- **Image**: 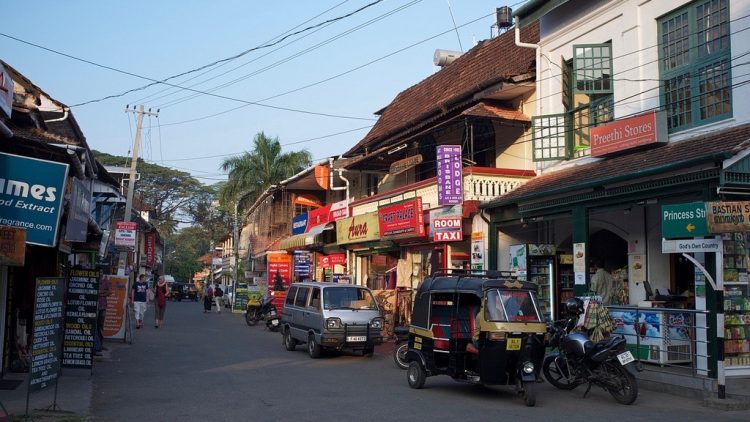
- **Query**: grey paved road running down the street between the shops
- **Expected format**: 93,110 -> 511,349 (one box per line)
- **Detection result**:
91,302 -> 747,422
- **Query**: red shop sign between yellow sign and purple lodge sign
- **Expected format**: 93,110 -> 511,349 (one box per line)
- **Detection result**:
378,196 -> 425,238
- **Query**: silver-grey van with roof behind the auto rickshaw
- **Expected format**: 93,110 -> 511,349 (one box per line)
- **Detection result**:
281,282 -> 383,358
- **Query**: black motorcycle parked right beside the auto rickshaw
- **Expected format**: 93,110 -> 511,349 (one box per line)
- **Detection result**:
542,298 -> 638,404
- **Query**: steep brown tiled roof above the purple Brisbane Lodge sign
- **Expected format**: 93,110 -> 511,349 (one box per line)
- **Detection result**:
344,23 -> 539,155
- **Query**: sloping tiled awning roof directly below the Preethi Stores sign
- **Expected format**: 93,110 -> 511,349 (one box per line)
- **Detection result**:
483,124 -> 750,208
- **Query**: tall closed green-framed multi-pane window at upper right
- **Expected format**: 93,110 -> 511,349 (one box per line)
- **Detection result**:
658,0 -> 732,132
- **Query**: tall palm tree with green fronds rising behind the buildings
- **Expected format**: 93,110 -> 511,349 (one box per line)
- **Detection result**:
220,132 -> 312,203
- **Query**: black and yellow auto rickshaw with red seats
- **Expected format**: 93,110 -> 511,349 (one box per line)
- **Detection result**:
406,270 -> 546,406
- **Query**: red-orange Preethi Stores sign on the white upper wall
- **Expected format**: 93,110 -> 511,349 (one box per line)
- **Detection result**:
590,111 -> 668,157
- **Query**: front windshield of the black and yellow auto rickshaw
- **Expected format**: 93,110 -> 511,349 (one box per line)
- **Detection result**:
485,289 -> 541,322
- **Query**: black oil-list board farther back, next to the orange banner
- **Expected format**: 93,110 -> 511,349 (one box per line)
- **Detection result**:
62,269 -> 99,368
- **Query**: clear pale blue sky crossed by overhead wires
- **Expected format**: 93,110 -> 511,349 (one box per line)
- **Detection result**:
0,0 -> 524,184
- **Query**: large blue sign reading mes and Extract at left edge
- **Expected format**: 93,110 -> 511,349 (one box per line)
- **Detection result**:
0,152 -> 68,246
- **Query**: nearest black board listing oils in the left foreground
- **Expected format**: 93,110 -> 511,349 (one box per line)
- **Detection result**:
29,277 -> 65,391
